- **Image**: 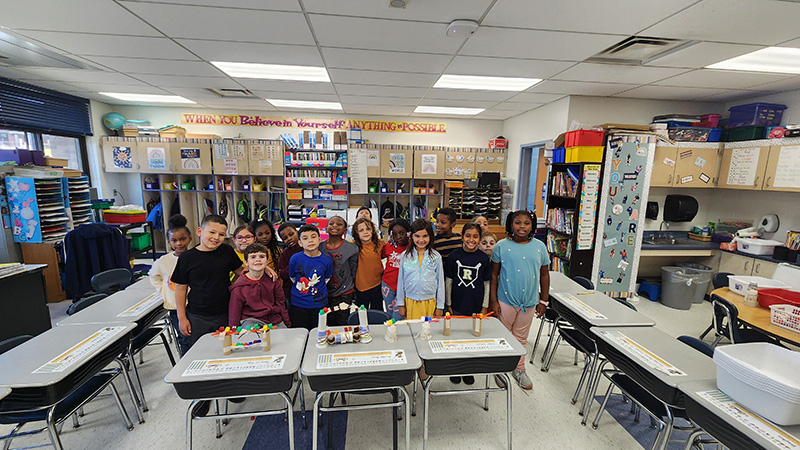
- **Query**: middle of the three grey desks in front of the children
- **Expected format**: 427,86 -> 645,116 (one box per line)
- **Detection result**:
300,325 -> 422,450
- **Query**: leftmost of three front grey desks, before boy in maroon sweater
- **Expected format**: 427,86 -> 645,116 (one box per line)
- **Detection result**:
164,328 -> 308,449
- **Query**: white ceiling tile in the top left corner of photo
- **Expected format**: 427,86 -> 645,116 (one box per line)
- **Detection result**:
0,0 -> 159,36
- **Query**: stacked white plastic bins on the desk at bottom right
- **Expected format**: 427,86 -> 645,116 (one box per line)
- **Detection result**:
714,344 -> 800,426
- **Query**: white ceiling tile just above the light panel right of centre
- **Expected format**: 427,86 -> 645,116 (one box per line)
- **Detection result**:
444,55 -> 574,79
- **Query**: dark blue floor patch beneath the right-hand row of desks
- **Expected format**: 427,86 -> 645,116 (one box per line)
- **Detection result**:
587,394 -> 716,450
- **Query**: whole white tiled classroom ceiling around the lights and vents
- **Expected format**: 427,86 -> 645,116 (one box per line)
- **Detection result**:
0,0 -> 800,120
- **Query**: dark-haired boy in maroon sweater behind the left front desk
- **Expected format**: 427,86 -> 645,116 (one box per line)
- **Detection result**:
228,243 -> 292,327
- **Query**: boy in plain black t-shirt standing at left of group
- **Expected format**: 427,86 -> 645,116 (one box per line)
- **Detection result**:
172,214 -> 277,347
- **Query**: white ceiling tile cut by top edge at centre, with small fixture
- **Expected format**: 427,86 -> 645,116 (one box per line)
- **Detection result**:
303,0 -> 492,21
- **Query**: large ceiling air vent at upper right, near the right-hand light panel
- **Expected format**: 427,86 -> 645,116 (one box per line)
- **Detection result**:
586,36 -> 697,66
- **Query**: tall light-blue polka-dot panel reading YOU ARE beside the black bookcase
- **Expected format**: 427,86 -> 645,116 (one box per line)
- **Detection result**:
592,134 -> 656,297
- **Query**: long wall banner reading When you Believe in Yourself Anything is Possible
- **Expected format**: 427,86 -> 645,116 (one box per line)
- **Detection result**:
181,113 -> 447,133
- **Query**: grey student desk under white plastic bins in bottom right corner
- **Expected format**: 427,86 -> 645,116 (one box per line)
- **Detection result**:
679,380 -> 800,450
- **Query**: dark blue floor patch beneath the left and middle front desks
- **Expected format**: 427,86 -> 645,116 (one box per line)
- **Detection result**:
242,411 -> 347,450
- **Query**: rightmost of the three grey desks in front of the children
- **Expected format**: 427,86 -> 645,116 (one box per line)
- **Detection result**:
410,317 -> 525,449
